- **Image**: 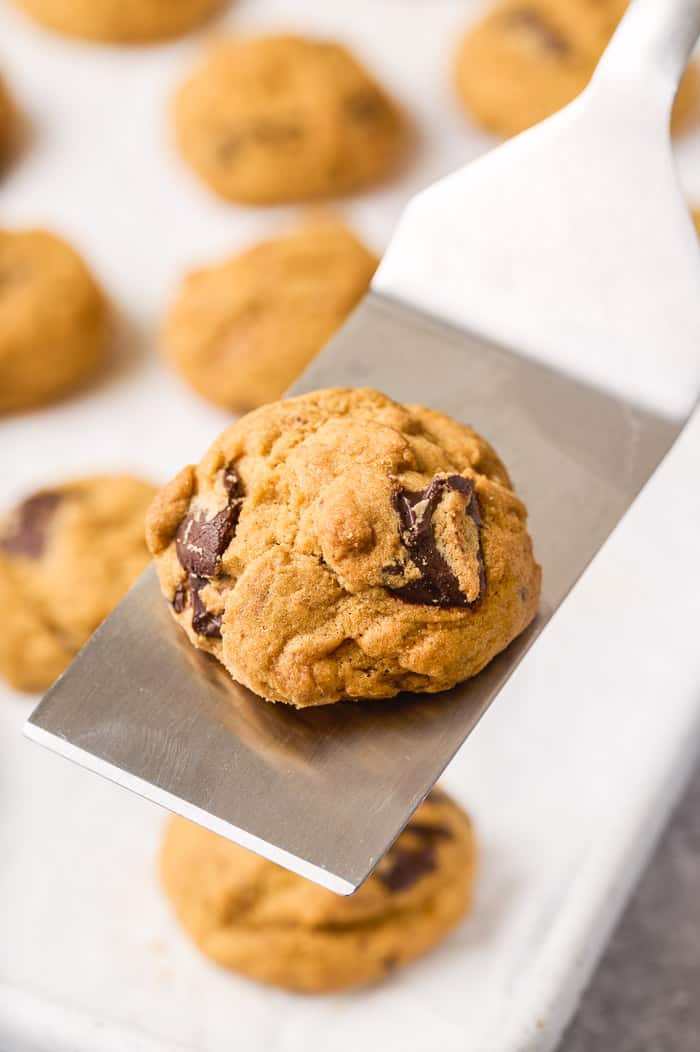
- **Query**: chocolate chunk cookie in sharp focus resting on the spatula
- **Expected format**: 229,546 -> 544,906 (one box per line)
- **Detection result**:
146,388 -> 540,707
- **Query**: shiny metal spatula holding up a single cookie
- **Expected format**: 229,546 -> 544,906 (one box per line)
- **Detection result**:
26,0 -> 700,893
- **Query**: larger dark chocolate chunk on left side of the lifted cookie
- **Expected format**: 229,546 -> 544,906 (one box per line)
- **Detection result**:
175,465 -> 243,578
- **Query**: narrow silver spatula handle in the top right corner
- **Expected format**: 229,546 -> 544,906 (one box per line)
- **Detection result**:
596,0 -> 700,107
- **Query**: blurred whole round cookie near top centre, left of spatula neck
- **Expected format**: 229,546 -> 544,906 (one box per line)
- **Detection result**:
175,36 -> 405,204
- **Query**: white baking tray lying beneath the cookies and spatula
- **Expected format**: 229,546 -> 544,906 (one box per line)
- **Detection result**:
0,0 -> 700,1052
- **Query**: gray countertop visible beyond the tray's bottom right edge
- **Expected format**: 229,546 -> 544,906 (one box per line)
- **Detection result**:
560,769 -> 700,1052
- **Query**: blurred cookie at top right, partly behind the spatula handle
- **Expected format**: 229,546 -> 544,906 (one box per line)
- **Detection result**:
455,0 -> 700,137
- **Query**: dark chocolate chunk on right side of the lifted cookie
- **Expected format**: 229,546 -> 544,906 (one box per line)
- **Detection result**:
389,474 -> 486,609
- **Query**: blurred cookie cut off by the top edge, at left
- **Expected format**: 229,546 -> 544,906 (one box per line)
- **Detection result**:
10,0 -> 224,44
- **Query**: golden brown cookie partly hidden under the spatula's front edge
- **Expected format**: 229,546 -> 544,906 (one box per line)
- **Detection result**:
161,790 -> 476,993
